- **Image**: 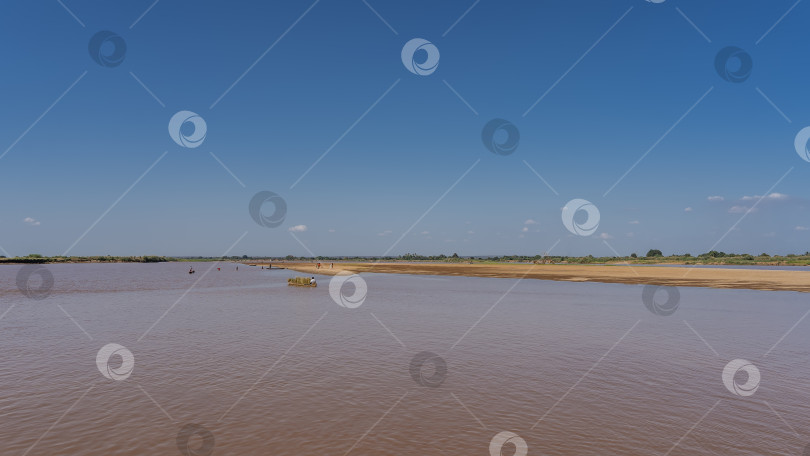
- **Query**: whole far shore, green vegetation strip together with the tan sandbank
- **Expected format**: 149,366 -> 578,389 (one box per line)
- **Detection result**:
0,256 -> 810,293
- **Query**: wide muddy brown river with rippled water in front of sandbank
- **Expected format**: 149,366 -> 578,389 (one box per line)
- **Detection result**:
0,263 -> 810,456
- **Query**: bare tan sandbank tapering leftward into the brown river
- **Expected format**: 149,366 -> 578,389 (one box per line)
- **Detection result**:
270,262 -> 810,293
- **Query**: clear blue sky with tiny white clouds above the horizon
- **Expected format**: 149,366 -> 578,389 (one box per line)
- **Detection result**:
0,0 -> 810,255
